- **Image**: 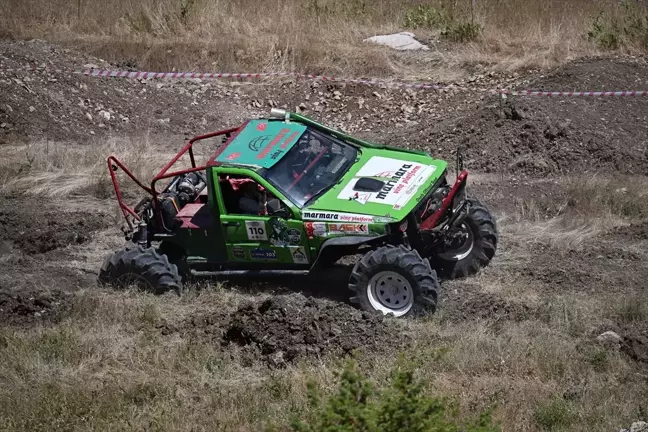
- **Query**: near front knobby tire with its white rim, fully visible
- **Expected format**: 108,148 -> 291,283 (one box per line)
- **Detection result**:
349,245 -> 439,317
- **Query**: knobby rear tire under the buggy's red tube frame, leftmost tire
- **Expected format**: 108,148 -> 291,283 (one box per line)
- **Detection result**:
99,244 -> 182,295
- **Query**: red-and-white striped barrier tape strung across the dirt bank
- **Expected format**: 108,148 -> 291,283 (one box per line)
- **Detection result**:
0,67 -> 648,97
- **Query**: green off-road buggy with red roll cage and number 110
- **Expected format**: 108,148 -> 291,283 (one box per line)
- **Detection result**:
99,109 -> 498,316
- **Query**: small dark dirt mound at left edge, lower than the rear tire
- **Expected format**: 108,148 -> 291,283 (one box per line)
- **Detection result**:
0,290 -> 71,325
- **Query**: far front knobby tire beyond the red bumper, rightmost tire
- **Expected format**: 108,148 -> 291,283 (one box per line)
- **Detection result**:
430,198 -> 499,279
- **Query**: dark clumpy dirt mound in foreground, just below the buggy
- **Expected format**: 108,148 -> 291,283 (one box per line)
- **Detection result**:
182,294 -> 408,366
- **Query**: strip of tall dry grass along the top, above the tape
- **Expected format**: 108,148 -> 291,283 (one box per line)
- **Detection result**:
0,0 -> 642,78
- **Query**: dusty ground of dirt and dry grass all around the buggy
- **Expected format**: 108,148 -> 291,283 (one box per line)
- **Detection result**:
0,41 -> 648,431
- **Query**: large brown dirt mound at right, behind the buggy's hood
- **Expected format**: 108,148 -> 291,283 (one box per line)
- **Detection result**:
374,58 -> 648,175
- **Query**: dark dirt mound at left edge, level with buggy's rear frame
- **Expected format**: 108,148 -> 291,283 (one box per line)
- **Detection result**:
0,197 -> 109,255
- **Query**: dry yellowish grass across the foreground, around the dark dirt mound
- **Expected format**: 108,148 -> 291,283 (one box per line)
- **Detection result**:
0,290 -> 648,431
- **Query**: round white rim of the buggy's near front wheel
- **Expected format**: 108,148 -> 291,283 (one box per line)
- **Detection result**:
367,271 -> 414,317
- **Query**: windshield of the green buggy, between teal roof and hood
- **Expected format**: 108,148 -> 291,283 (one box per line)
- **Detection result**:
265,129 -> 358,208
